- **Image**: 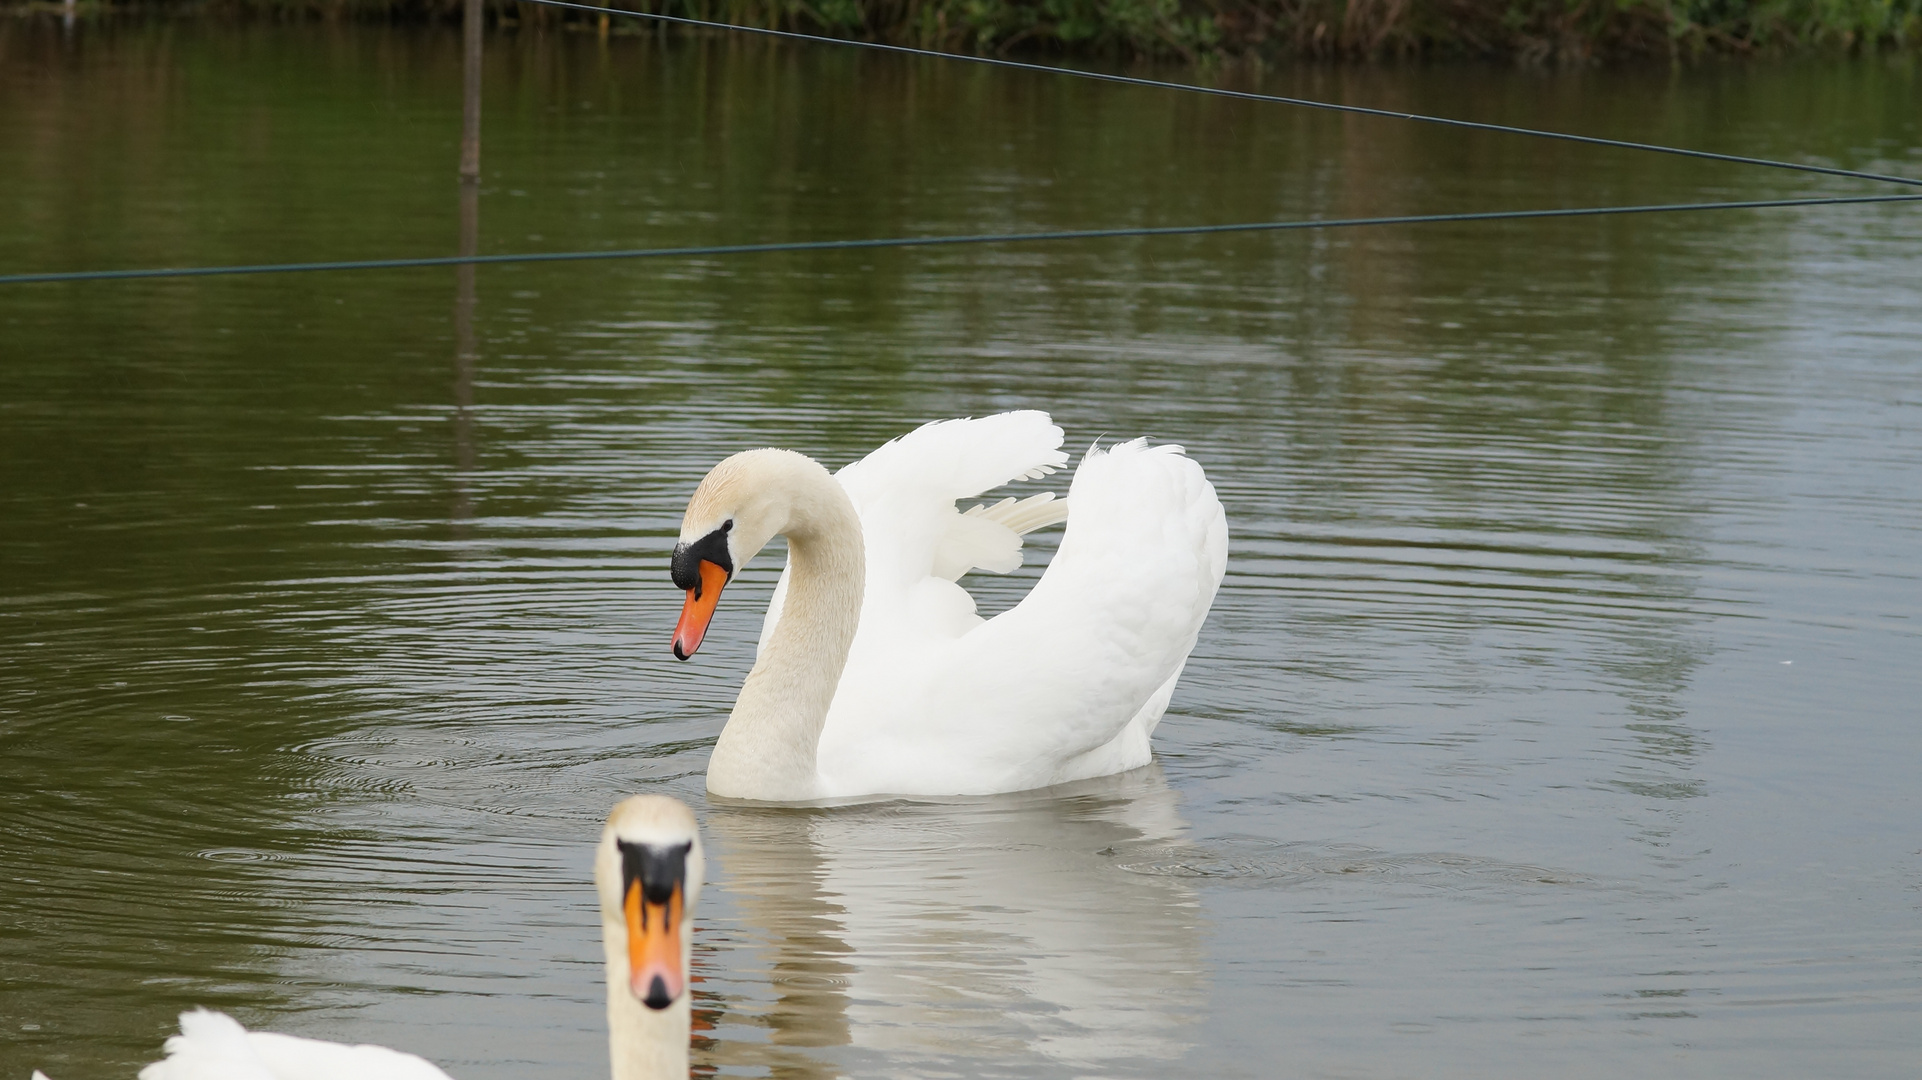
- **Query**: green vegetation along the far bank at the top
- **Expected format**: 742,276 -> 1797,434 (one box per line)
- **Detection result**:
0,0 -> 1922,63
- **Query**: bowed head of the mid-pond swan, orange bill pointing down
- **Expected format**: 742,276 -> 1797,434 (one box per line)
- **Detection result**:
673,450 -> 838,659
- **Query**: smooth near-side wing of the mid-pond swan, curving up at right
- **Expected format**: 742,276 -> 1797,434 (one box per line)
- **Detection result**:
823,440 -> 1228,794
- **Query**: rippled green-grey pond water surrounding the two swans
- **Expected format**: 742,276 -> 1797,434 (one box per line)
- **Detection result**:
0,19 -> 1922,1080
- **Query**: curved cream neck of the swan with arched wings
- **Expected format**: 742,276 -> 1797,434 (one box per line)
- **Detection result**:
707,455 -> 867,801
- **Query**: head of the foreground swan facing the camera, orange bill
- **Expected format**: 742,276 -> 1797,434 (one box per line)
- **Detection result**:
594,796 -> 705,1011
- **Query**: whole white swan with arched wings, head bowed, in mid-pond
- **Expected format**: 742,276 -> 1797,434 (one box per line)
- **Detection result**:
673,411 -> 1228,801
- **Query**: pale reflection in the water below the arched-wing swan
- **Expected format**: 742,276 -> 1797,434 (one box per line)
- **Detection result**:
696,765 -> 1207,1076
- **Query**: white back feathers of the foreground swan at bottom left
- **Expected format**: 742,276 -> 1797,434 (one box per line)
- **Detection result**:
140,1009 -> 450,1080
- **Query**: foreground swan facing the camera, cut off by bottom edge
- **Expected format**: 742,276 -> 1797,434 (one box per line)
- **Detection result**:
60,796 -> 705,1080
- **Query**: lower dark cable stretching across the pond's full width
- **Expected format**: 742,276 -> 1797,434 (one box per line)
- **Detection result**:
0,194 -> 1922,284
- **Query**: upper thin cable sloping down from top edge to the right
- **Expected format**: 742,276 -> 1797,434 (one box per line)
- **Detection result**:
527,0 -> 1922,186
